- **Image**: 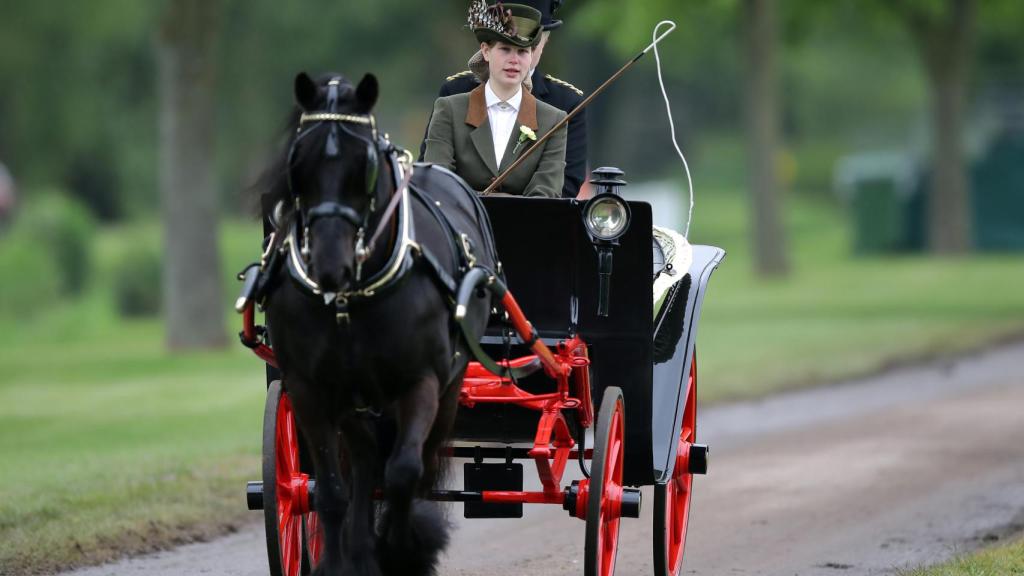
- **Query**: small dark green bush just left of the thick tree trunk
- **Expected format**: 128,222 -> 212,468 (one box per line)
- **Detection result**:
113,240 -> 163,318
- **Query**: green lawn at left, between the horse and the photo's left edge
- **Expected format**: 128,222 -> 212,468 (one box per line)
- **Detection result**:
0,218 -> 264,574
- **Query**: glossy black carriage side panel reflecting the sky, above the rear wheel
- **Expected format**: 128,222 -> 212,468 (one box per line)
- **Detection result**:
651,245 -> 725,483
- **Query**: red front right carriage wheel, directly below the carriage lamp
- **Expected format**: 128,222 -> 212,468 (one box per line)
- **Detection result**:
584,386 -> 626,576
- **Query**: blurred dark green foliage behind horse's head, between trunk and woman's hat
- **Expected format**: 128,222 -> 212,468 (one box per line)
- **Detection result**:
216,0 -> 464,205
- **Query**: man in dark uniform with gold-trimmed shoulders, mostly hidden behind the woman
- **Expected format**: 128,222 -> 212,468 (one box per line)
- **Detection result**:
420,0 -> 587,198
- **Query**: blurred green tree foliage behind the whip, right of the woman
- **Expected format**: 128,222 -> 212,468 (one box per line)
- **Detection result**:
573,0 -> 742,170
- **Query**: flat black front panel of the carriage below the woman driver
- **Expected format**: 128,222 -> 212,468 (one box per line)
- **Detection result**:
455,197 -> 654,485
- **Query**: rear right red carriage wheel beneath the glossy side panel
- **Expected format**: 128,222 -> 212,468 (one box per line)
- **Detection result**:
654,352 -> 697,576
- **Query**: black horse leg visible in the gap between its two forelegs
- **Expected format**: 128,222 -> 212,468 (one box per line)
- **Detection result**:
342,418 -> 380,576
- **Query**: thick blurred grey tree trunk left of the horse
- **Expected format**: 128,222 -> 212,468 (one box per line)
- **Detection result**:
158,0 -> 227,348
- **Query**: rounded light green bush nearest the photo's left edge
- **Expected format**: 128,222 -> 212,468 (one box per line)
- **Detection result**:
16,192 -> 96,296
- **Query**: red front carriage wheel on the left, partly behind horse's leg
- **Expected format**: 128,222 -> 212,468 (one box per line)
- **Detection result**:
263,380 -> 309,576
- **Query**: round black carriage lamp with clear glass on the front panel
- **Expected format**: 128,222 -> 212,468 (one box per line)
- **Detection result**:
583,167 -> 631,317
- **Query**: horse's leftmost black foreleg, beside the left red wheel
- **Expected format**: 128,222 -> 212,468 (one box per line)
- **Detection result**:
292,384 -> 348,575
